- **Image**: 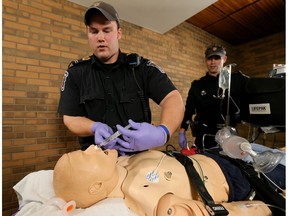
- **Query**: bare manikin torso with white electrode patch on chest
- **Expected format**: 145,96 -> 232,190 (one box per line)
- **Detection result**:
109,150 -> 228,215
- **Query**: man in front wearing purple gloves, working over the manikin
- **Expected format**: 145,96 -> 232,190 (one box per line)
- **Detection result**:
58,2 -> 184,154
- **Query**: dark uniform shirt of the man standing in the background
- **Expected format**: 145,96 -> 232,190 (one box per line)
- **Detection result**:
181,71 -> 248,130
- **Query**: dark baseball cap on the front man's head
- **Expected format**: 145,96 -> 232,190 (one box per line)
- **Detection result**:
84,1 -> 120,27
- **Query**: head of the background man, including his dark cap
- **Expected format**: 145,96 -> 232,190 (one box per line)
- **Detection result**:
205,44 -> 227,76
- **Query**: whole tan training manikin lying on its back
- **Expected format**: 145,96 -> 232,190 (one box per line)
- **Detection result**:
53,146 -> 271,216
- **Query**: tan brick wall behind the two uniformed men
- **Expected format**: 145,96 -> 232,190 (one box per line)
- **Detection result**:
2,0 -> 285,216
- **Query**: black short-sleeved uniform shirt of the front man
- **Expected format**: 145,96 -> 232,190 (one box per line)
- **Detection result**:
58,51 -> 176,144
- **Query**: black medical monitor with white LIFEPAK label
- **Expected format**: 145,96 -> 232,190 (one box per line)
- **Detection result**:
240,77 -> 285,127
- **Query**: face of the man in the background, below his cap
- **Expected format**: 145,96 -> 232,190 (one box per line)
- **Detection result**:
206,55 -> 227,76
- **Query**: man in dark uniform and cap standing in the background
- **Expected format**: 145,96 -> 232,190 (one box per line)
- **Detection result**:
178,44 -> 248,151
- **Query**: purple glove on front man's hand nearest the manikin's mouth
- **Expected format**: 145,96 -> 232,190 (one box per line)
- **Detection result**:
91,122 -> 117,146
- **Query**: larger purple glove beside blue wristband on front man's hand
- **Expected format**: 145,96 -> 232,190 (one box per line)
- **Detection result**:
116,120 -> 169,152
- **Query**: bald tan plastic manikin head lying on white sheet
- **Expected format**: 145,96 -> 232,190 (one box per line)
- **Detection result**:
53,145 -> 119,208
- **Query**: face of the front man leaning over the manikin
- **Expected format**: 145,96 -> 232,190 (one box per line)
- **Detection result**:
87,14 -> 122,64
